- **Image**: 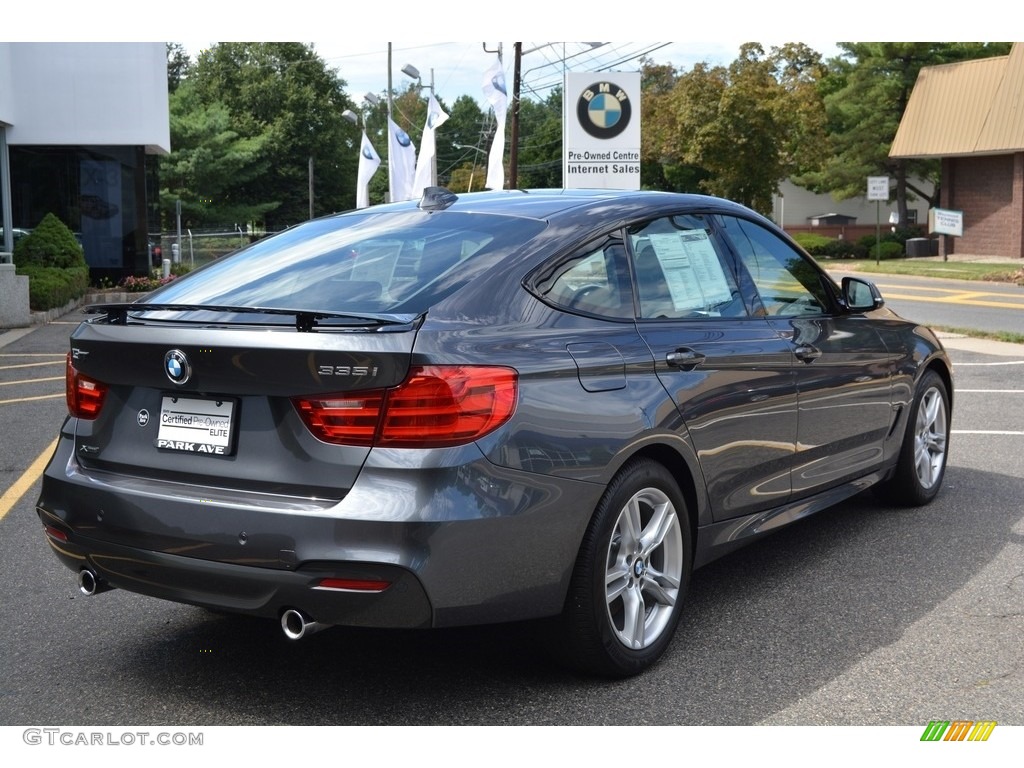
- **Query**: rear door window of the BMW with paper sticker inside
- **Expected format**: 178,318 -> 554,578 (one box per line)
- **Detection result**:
630,215 -> 746,319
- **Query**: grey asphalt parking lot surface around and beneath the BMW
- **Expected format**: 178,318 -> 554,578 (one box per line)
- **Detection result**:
0,312 -> 1024,732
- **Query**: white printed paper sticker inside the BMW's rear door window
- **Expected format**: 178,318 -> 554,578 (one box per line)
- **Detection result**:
648,229 -> 732,310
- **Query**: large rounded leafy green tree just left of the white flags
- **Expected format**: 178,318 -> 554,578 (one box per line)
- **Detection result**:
163,43 -> 358,229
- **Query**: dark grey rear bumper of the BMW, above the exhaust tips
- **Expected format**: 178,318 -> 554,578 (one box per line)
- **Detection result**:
37,433 -> 601,628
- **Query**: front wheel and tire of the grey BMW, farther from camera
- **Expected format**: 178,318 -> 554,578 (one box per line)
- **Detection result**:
879,371 -> 950,507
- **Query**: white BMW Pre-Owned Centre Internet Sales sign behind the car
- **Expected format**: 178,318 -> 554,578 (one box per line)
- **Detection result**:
562,72 -> 640,189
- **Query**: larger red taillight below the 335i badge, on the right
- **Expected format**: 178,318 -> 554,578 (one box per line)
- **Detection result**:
294,366 -> 517,449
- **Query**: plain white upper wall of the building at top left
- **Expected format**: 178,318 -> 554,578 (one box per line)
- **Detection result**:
0,43 -> 171,154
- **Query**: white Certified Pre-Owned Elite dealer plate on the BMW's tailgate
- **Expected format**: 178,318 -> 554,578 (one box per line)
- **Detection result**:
157,395 -> 234,456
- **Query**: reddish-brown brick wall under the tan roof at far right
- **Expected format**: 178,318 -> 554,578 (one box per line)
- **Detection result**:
942,153 -> 1024,258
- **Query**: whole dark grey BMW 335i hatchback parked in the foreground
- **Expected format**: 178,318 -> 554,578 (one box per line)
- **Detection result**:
38,188 -> 953,677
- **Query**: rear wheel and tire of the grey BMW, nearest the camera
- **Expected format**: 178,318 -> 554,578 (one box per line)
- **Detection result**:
561,459 -> 693,678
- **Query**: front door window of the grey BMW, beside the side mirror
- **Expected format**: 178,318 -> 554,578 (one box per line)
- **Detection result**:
719,216 -> 830,317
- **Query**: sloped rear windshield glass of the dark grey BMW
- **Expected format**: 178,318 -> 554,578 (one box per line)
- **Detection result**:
146,211 -> 546,314
